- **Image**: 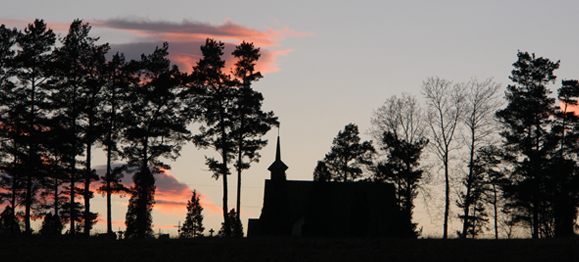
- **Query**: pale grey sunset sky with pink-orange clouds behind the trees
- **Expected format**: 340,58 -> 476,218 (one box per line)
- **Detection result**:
0,0 -> 579,236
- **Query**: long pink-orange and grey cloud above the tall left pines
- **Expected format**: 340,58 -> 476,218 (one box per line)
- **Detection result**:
92,19 -> 312,74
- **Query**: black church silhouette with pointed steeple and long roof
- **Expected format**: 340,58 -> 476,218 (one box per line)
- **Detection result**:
247,136 -> 411,237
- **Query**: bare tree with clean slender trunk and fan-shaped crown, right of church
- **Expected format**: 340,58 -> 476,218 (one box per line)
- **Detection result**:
422,77 -> 466,239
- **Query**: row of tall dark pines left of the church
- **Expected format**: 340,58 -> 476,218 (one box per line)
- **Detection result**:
0,19 -> 278,238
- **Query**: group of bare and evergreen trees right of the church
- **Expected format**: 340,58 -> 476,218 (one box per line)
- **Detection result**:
314,52 -> 579,238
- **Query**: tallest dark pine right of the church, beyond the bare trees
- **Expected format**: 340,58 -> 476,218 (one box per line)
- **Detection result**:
496,51 -> 559,238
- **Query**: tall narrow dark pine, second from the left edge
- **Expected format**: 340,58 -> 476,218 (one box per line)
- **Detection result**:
10,19 -> 56,234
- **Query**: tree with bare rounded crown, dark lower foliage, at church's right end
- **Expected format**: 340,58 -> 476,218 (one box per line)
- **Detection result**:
371,94 -> 428,237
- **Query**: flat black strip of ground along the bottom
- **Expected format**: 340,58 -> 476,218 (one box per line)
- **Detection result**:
0,237 -> 579,262
